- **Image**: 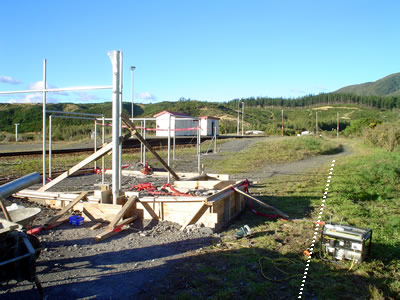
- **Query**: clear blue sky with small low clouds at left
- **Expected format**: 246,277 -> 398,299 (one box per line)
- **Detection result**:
0,0 -> 400,103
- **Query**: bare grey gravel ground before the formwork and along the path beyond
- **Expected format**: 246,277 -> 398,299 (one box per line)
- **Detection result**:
0,139 -> 349,299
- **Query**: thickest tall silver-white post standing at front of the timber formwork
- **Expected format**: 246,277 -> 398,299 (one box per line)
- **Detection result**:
110,50 -> 120,205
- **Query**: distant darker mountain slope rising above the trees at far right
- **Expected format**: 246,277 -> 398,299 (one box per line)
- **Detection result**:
336,73 -> 400,96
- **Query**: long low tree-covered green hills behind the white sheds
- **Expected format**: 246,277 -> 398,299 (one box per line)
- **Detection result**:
0,91 -> 400,141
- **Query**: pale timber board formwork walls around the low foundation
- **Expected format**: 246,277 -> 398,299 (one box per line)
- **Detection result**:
14,181 -> 245,230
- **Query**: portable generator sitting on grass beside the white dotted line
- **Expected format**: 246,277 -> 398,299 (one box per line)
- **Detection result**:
321,224 -> 372,263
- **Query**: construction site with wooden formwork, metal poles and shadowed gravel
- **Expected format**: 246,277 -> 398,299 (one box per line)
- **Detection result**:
0,51 -> 298,299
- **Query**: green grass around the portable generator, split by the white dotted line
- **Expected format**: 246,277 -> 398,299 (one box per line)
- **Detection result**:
148,142 -> 400,299
